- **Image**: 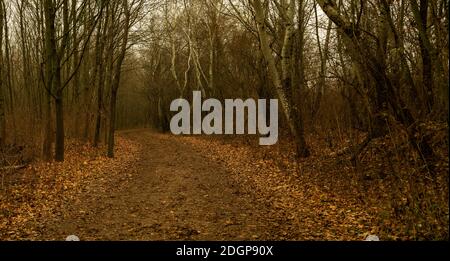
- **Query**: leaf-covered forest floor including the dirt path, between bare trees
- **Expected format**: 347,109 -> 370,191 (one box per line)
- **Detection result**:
0,130 -> 448,240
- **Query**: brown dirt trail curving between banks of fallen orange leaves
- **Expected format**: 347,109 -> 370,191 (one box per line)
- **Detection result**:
43,131 -> 279,240
